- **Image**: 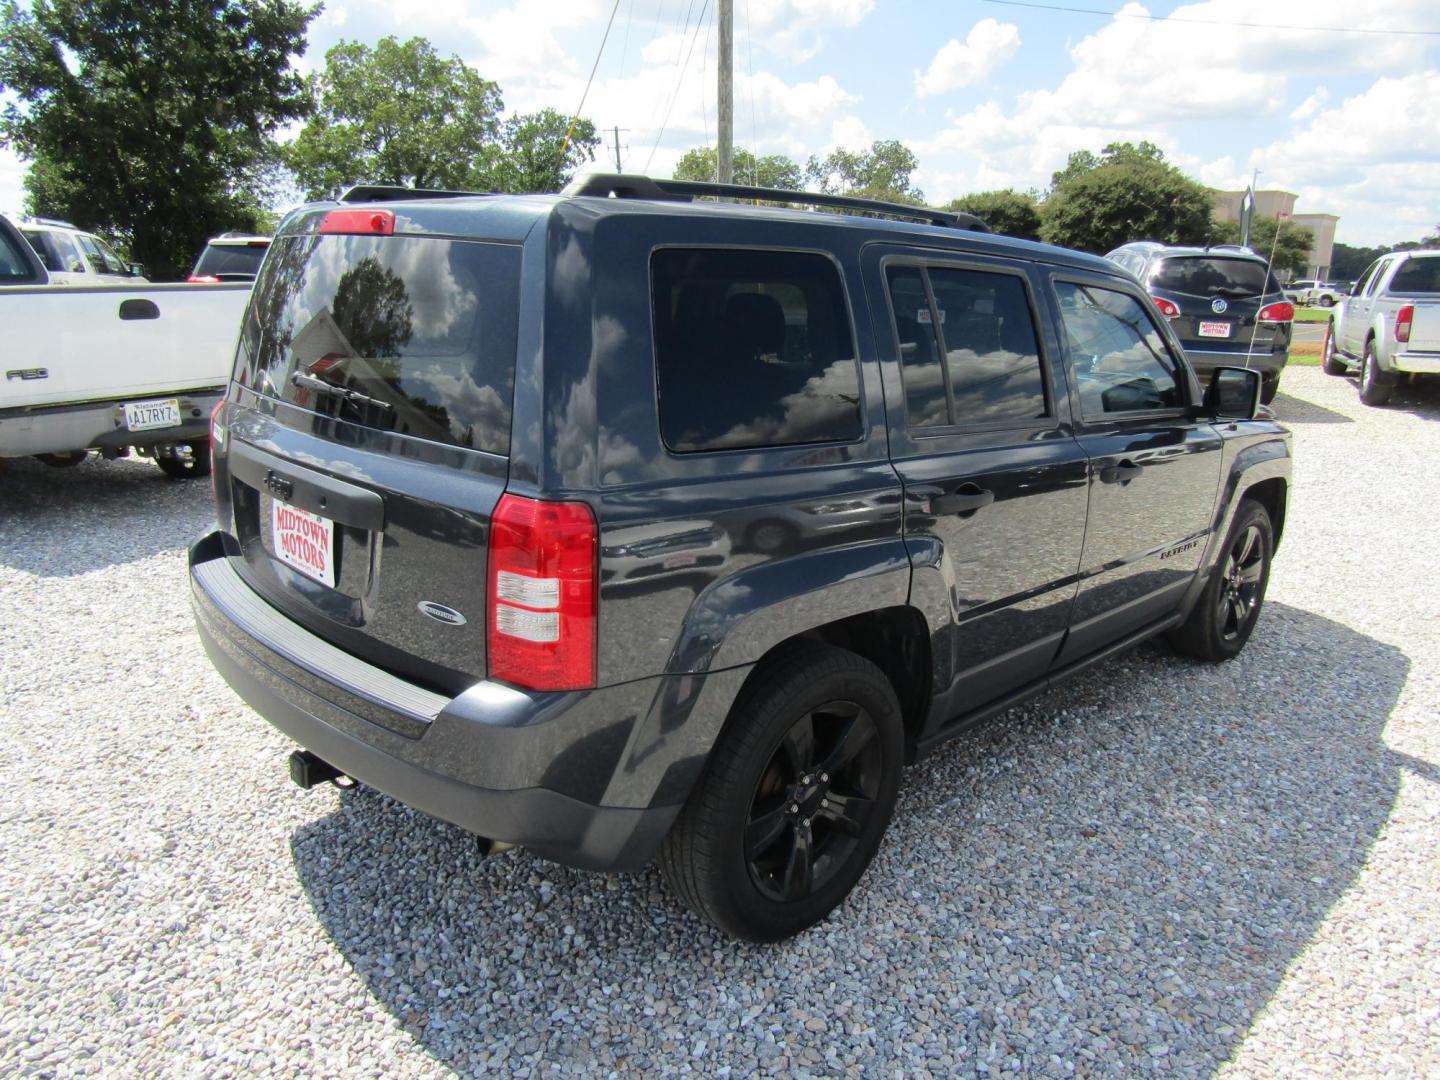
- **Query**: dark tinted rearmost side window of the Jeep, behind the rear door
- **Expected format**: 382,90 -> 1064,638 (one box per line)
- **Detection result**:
651,249 -> 861,451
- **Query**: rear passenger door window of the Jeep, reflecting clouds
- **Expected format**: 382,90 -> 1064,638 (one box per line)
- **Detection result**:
887,266 -> 1048,428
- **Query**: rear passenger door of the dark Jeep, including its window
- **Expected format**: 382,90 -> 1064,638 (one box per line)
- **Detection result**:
865,248 -> 1086,723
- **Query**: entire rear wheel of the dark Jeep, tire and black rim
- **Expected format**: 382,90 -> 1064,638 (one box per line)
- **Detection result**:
660,642 -> 904,942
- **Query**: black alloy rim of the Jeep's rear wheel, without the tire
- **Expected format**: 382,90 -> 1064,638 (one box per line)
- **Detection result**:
744,701 -> 881,901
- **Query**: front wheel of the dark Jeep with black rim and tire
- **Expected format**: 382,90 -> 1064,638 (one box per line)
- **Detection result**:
1169,498 -> 1274,662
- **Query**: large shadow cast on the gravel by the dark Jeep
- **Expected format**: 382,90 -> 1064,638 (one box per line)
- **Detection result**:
291,603 -> 1405,1076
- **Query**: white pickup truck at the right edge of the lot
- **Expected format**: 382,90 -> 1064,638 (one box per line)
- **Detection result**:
1322,251 -> 1440,405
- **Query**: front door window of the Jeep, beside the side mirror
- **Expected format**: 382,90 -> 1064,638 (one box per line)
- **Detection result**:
1056,281 -> 1185,416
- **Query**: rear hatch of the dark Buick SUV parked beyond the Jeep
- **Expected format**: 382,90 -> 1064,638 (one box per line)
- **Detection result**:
1149,253 -> 1293,357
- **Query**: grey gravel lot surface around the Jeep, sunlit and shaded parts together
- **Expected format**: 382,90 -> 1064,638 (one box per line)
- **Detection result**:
0,369 -> 1440,1077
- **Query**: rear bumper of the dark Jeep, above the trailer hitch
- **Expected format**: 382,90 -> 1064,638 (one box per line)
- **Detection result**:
190,533 -> 743,870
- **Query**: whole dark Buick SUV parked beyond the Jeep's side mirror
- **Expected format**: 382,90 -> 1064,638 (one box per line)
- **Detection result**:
1106,240 -> 1295,405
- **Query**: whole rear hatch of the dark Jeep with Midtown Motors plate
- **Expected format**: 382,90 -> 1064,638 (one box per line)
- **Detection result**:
217,223 -> 521,693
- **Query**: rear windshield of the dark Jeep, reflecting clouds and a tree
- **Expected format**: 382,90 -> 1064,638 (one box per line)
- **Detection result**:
236,235 -> 520,454
